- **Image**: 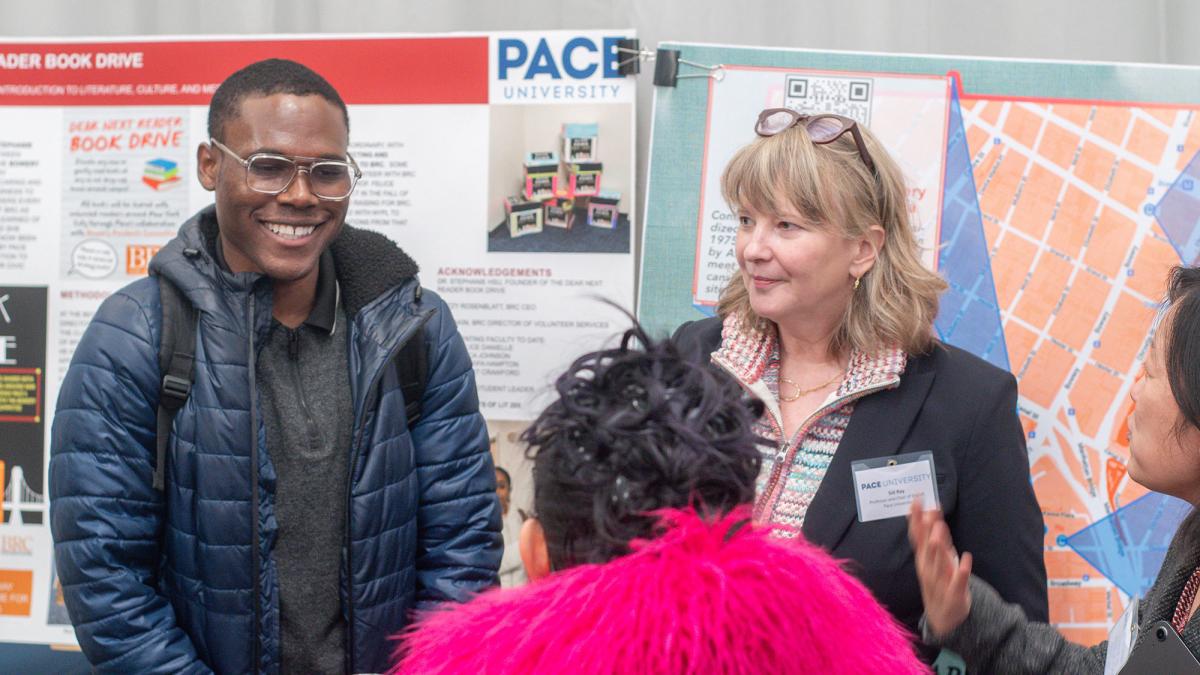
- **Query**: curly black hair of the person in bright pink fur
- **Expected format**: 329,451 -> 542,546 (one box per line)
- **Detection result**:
522,324 -> 762,569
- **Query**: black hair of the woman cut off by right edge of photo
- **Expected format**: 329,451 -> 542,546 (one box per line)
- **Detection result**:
1165,267 -> 1200,432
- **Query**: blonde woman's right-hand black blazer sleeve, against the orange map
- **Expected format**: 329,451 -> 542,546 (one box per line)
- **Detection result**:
949,372 -> 1049,621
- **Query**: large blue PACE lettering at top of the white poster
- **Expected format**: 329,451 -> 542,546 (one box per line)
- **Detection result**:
496,37 -> 623,79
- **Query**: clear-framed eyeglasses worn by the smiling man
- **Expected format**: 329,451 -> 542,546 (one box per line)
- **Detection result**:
209,138 -> 362,202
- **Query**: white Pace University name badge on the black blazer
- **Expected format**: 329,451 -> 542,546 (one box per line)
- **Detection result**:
850,453 -> 941,522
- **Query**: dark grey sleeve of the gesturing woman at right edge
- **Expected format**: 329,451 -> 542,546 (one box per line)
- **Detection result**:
922,575 -> 1104,675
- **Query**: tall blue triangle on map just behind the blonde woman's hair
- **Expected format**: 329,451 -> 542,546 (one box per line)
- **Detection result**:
934,88 -> 1009,370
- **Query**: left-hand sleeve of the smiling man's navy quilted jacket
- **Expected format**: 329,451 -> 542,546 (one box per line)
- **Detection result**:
49,285 -> 210,673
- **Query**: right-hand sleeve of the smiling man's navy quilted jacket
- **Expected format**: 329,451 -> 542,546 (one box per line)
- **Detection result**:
412,292 -> 504,609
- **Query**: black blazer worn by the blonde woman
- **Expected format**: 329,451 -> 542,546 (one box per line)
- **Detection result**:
673,318 -> 1049,635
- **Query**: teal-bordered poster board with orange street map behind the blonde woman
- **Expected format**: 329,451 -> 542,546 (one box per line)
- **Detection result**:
638,43 -> 1200,644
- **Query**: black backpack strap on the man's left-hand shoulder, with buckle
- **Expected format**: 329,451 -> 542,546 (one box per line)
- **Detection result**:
154,275 -> 196,490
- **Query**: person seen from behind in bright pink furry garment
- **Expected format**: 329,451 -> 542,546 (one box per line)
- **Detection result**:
394,327 -> 925,674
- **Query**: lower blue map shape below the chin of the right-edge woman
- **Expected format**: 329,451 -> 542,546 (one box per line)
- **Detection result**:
1061,492 -> 1192,597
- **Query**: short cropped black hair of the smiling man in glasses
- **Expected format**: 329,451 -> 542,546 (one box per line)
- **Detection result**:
209,59 -> 350,141
